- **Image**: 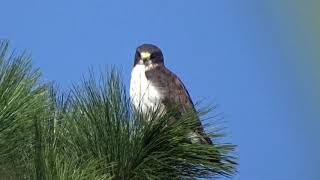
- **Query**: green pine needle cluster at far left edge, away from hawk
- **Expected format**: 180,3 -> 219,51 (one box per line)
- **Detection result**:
0,41 -> 45,179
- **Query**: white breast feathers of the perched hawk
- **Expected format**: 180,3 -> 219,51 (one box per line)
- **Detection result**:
130,65 -> 161,112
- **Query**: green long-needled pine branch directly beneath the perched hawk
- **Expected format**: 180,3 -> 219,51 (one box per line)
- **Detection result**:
49,70 -> 236,179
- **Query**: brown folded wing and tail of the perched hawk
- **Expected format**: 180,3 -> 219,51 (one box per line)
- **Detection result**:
146,66 -> 212,144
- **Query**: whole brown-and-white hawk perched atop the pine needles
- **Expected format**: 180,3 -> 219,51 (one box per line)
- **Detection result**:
130,44 -> 212,144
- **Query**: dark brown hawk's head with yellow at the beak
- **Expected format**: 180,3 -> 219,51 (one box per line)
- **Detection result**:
134,44 -> 163,66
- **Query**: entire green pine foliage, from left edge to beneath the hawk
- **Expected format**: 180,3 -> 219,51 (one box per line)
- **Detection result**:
0,42 -> 236,180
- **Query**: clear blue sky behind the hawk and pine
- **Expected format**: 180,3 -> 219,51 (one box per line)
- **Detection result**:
0,0 -> 320,180
